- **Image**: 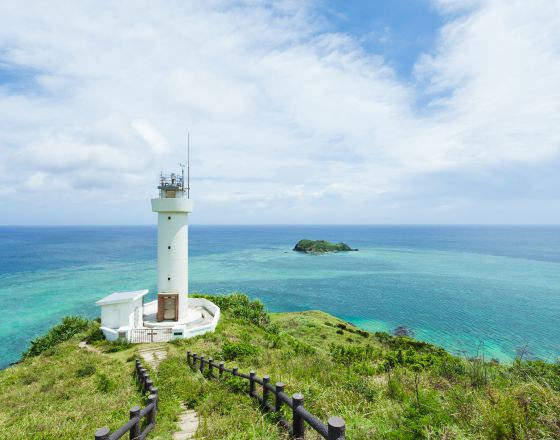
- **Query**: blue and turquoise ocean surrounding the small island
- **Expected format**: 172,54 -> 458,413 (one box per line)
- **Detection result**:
0,225 -> 560,367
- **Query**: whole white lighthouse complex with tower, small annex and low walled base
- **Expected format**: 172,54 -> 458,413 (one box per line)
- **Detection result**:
96,168 -> 220,342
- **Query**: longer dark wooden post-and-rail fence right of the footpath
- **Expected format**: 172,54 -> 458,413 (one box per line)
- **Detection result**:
187,351 -> 346,440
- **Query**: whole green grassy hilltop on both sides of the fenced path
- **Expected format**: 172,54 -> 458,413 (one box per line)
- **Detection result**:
0,295 -> 560,440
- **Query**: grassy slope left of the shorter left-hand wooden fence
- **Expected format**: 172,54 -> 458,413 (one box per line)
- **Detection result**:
0,335 -> 142,439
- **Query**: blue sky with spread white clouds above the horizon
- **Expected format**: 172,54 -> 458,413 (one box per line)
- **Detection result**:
0,0 -> 560,225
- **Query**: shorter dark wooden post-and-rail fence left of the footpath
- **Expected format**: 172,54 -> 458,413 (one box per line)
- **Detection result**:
95,359 -> 159,440
